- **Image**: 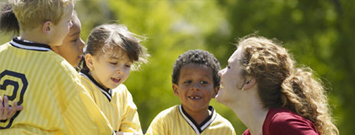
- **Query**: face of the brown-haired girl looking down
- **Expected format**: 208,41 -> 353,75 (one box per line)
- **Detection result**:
86,50 -> 132,89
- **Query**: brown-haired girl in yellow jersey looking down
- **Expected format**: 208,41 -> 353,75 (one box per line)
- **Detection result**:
80,24 -> 148,134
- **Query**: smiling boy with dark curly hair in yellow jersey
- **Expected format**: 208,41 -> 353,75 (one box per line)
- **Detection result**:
146,50 -> 235,135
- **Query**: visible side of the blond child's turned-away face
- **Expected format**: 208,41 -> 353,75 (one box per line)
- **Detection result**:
49,4 -> 74,46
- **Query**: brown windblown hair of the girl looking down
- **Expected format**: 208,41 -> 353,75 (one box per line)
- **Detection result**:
81,24 -> 149,71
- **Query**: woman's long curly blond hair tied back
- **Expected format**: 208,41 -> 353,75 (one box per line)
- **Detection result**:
238,36 -> 339,135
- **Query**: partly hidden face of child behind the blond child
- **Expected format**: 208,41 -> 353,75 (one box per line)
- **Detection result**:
52,15 -> 85,67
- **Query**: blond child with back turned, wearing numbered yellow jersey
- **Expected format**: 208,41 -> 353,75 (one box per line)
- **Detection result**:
0,0 -> 113,134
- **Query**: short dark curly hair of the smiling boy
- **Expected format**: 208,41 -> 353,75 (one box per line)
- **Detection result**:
172,49 -> 221,87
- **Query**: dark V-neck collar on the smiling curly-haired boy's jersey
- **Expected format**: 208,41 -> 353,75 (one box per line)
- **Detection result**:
179,105 -> 217,135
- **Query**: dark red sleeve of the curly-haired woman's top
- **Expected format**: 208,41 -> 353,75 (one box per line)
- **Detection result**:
269,115 -> 318,135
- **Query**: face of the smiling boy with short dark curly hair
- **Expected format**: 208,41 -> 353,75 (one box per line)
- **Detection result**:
173,63 -> 218,114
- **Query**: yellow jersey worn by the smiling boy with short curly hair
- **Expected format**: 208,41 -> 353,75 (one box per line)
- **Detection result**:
146,105 -> 235,135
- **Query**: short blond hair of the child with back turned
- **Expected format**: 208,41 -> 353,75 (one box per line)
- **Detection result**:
9,0 -> 74,30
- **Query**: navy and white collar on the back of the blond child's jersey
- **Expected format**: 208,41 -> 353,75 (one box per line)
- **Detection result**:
10,37 -> 51,51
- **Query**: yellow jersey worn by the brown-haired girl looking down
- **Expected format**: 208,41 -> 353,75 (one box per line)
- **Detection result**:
80,73 -> 143,134
